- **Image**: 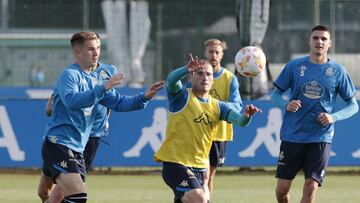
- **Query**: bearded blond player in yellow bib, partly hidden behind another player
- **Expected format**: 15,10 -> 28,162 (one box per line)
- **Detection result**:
204,39 -> 242,199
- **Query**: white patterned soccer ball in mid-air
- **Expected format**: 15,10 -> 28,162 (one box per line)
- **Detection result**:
235,46 -> 266,77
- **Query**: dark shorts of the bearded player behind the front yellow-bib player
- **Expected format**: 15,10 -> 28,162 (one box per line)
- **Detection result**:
209,141 -> 227,167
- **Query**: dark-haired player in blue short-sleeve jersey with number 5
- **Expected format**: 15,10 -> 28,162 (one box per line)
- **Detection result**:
272,25 -> 359,203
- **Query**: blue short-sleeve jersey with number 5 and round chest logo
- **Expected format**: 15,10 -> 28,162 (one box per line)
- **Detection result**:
274,56 -> 356,143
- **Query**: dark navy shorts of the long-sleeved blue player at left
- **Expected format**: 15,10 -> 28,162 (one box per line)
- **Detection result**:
41,138 -> 86,183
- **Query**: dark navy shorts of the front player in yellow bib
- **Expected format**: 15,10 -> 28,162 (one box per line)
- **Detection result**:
162,162 -> 206,202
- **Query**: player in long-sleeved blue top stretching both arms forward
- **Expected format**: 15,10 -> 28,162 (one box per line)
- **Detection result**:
37,32 -> 163,203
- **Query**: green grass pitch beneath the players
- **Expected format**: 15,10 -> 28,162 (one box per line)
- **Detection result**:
0,172 -> 360,203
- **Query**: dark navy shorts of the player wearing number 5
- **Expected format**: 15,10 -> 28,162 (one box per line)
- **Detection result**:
276,141 -> 331,186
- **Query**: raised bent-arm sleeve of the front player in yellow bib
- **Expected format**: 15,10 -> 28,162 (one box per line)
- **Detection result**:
166,66 -> 189,94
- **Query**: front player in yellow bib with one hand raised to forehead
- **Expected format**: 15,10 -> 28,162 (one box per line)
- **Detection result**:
154,54 -> 261,203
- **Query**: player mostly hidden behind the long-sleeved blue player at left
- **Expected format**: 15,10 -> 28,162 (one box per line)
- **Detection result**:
38,63 -> 118,203
